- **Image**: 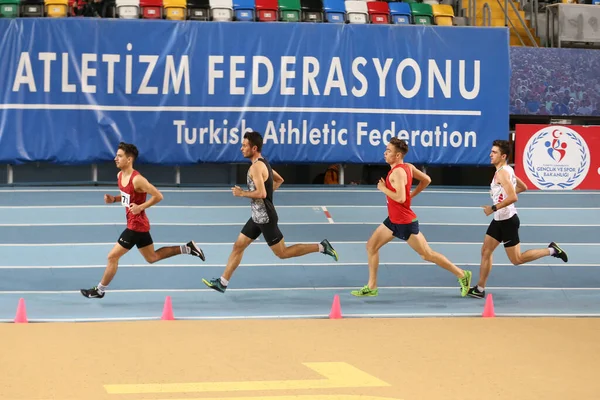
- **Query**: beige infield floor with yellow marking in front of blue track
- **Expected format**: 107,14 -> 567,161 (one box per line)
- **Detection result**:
0,318 -> 600,400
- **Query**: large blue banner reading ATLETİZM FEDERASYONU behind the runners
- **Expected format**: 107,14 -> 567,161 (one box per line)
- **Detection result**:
0,18 -> 509,165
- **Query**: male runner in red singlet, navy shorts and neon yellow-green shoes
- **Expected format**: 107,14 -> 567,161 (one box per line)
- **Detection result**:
351,138 -> 472,297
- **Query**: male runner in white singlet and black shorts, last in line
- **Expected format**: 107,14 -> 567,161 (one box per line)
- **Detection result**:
468,140 -> 568,299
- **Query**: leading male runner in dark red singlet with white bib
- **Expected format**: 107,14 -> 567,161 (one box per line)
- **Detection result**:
81,142 -> 204,299
